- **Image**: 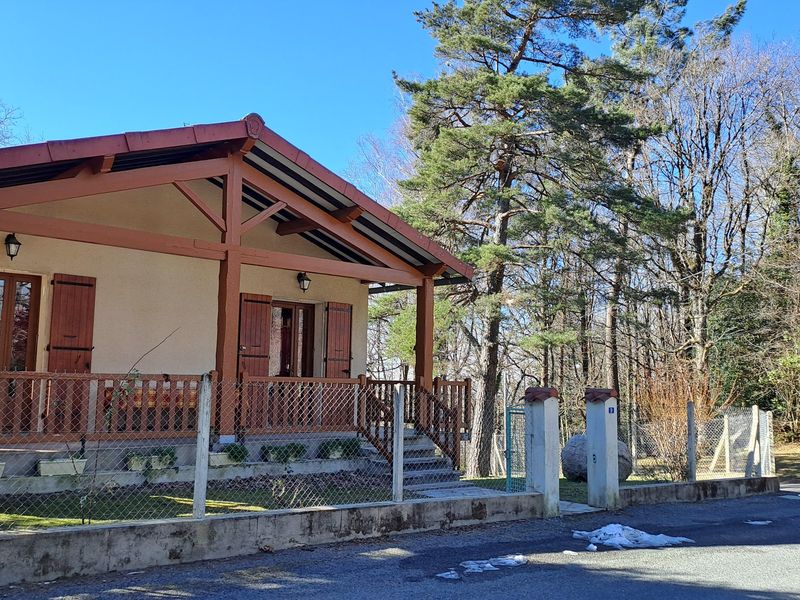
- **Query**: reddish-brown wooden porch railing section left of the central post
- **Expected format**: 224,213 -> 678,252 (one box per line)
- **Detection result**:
0,371 -> 209,442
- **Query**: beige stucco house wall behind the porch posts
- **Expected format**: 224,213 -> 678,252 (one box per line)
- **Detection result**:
0,182 -> 367,375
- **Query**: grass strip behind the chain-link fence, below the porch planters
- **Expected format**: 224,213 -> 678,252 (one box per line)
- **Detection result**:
0,484 -> 392,530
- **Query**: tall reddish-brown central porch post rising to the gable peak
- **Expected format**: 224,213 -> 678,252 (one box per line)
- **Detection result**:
217,157 -> 242,436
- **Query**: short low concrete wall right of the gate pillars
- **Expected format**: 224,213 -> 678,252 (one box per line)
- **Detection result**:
619,477 -> 780,507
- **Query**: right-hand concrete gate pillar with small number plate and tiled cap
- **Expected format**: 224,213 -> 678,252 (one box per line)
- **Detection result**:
586,388 -> 619,509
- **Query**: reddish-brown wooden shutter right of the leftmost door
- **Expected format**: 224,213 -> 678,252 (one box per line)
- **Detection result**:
47,273 -> 96,373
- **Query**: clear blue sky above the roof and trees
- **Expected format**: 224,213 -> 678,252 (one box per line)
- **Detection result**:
0,0 -> 800,173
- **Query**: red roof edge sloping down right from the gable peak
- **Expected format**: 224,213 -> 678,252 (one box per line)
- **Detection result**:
260,127 -> 475,279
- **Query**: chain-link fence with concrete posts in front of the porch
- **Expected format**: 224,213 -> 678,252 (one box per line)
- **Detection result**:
0,372 -> 476,530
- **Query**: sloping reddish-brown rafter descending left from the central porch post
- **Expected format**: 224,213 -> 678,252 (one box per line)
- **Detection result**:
0,158 -> 229,209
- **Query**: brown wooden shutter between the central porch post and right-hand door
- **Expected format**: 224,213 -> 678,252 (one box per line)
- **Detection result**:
239,294 -> 272,377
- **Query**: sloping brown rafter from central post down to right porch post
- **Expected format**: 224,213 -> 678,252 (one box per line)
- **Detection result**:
242,164 -> 419,279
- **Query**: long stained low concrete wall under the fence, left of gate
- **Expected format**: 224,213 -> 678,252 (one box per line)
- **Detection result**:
0,493 -> 542,585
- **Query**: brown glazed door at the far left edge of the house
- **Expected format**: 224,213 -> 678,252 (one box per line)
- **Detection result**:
0,273 -> 41,371
